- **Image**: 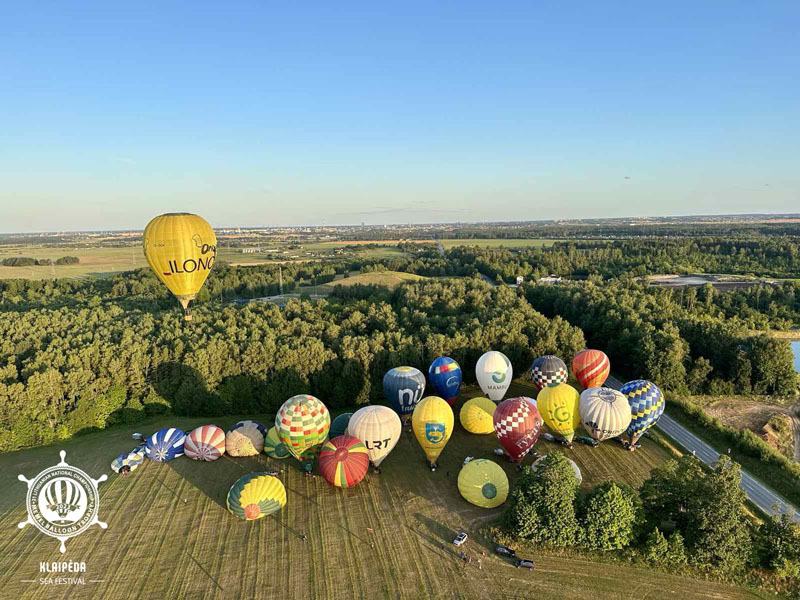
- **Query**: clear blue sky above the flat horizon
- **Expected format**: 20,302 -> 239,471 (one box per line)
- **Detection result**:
0,0 -> 800,231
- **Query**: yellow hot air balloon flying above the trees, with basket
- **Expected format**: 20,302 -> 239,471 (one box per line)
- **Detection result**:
142,213 -> 217,321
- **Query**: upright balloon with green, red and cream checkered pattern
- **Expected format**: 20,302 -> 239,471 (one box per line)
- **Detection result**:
275,394 -> 331,468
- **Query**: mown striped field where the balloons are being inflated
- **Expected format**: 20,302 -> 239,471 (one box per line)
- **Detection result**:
0,384 -> 758,600
